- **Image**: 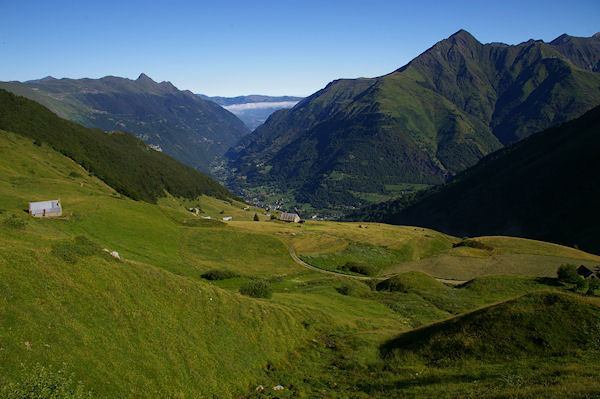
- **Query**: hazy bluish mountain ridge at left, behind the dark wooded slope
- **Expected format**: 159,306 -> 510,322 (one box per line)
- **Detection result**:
0,74 -> 249,172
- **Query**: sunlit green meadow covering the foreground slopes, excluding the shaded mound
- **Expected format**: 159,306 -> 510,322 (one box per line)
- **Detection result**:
0,132 -> 600,398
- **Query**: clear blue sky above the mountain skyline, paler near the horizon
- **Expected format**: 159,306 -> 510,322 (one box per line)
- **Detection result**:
0,0 -> 600,96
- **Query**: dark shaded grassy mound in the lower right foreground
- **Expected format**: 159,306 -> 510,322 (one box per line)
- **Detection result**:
382,292 -> 600,362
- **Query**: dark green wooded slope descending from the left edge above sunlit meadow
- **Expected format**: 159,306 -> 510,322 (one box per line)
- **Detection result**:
0,90 -> 233,202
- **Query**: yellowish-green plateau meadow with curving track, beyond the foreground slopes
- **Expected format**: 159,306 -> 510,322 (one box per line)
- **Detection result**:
236,217 -> 600,280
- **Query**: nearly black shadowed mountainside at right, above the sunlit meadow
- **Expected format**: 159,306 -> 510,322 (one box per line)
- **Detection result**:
351,107 -> 600,253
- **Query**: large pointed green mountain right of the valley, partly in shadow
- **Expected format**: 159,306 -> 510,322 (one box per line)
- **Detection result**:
226,31 -> 600,209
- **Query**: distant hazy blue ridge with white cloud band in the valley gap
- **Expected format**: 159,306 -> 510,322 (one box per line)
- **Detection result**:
198,94 -> 302,130
